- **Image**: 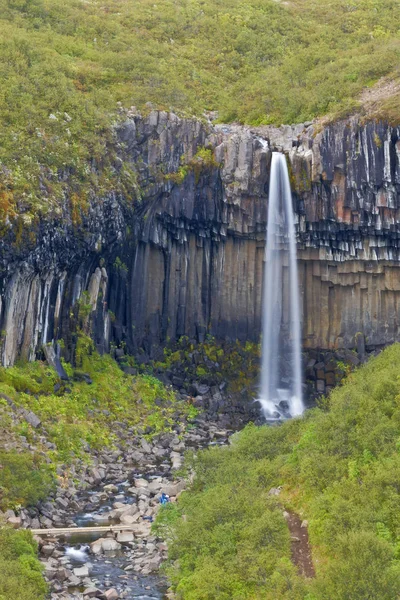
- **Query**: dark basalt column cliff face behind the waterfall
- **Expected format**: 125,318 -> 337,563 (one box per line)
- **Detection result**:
0,111 -> 400,365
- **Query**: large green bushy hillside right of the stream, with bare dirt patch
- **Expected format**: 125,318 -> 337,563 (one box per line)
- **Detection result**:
157,344 -> 400,600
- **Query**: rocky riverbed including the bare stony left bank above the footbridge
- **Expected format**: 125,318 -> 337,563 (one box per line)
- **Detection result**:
8,417 -> 232,600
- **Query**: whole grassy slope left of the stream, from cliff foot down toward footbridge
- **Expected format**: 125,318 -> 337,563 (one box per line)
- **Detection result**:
0,338 -> 196,509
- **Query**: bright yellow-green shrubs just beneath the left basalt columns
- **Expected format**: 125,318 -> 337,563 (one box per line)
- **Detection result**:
0,353 -> 189,460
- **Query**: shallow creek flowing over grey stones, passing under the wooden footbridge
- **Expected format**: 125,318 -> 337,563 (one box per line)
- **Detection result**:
40,423 -> 232,600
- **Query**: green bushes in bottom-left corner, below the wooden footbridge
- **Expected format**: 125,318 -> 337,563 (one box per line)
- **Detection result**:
0,528 -> 47,600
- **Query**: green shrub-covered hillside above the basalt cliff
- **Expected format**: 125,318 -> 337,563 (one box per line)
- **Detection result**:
0,0 -> 400,218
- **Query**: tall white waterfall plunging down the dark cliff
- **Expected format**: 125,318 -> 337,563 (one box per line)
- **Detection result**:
259,152 -> 304,419
